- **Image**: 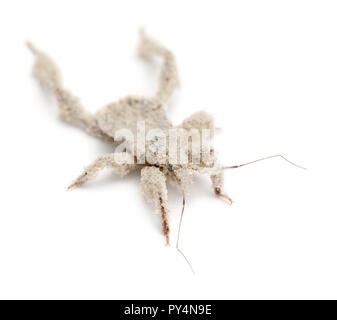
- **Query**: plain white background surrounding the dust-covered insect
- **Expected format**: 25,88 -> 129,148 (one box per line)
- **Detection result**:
0,0 -> 337,299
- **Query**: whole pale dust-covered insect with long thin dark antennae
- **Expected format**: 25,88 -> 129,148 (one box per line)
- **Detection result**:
28,31 -> 304,272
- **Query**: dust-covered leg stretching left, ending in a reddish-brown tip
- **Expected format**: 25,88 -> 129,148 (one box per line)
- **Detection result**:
68,152 -> 137,190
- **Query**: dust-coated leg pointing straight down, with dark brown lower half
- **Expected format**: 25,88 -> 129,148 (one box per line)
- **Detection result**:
141,167 -> 170,245
